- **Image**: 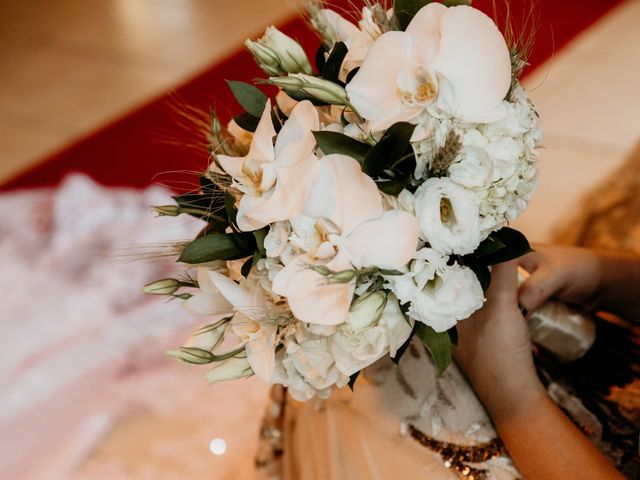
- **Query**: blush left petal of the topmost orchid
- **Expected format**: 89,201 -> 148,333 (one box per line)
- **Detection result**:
346,32 -> 423,131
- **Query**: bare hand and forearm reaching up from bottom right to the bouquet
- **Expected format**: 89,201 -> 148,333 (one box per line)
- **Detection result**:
454,262 -> 624,480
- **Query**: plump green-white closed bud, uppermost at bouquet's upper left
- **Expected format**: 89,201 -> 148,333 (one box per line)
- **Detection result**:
245,26 -> 313,77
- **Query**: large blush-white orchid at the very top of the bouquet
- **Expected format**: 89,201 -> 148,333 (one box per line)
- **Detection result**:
346,2 -> 511,131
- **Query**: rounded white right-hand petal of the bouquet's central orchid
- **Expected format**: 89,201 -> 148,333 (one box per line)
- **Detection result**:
346,210 -> 420,269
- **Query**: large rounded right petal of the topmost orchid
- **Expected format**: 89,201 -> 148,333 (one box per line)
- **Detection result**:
433,5 -> 511,122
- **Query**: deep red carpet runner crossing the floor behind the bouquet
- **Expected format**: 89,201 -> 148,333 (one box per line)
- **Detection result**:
0,0 -> 621,190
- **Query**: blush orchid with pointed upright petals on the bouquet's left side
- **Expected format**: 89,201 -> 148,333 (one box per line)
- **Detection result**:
217,101 -> 320,231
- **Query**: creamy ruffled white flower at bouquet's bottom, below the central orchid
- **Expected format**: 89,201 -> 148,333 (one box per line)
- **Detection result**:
332,291 -> 412,376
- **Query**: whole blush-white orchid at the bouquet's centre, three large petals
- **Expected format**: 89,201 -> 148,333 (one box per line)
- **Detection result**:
273,154 -> 419,325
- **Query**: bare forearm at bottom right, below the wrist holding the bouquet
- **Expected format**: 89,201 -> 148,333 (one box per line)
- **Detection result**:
486,386 -> 624,480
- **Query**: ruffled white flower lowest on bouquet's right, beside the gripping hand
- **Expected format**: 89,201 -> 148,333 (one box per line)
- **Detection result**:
387,248 -> 484,332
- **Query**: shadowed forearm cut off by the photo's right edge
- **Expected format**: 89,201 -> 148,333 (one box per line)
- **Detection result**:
596,253 -> 640,319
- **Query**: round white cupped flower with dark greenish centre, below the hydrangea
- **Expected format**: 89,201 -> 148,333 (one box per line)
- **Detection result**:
414,178 -> 482,255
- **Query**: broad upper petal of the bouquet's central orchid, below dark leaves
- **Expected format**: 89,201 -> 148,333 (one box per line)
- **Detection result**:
304,154 -> 382,235
